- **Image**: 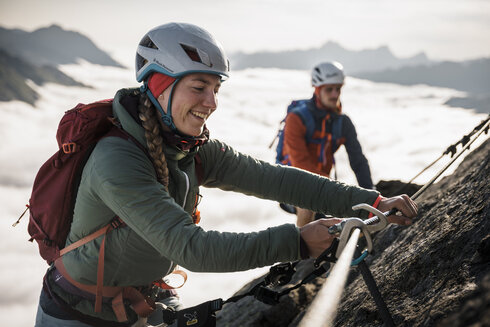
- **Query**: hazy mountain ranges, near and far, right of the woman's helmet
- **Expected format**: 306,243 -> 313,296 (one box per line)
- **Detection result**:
230,41 -> 490,113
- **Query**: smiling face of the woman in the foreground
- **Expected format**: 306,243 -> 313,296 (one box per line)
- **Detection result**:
158,73 -> 221,136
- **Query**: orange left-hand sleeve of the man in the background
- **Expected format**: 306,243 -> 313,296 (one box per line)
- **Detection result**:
284,113 -> 322,174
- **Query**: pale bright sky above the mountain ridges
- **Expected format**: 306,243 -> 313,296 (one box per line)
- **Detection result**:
0,0 -> 490,67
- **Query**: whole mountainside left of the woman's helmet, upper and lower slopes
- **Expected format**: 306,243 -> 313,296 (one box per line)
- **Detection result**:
0,25 -> 123,105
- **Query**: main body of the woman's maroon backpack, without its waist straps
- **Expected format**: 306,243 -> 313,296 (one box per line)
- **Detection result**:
20,100 -> 130,264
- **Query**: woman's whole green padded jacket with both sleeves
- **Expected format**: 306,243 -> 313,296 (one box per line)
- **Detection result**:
50,89 -> 378,320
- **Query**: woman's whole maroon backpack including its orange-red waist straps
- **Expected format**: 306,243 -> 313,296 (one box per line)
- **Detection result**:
14,99 -> 193,321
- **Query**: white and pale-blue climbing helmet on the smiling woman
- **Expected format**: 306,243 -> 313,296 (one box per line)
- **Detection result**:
136,23 -> 230,82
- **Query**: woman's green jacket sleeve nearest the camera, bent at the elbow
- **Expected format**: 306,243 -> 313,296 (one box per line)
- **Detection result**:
85,137 -> 300,273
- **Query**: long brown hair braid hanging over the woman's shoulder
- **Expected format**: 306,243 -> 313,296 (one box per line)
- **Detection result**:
138,93 -> 168,190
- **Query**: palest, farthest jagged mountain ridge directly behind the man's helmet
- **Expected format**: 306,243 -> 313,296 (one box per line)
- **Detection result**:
230,41 -> 433,74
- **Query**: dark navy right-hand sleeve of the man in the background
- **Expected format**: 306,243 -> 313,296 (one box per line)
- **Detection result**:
342,116 -> 373,189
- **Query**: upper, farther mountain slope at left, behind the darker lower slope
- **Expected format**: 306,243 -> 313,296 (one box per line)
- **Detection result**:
0,25 -> 123,67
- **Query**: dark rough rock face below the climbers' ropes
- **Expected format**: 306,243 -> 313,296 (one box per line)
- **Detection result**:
217,136 -> 490,327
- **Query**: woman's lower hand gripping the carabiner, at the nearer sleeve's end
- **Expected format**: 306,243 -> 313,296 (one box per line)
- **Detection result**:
299,218 -> 342,258
